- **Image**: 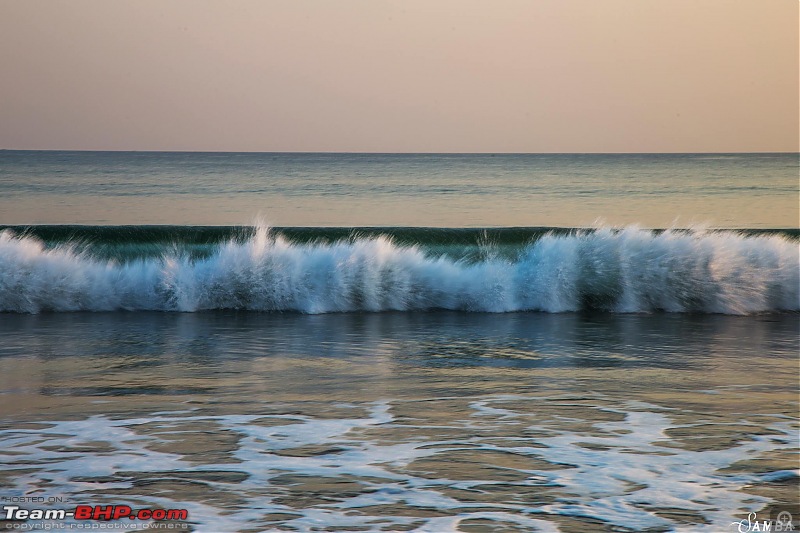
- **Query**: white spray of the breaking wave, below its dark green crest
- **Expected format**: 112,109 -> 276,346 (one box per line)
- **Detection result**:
0,227 -> 800,314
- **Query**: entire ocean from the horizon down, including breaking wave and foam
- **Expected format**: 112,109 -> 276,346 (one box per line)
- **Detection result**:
0,151 -> 800,533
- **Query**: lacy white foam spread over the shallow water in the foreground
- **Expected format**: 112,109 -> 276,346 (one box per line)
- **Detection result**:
0,395 -> 797,532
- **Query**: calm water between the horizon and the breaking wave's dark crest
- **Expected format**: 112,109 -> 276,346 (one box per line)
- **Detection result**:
0,151 -> 800,228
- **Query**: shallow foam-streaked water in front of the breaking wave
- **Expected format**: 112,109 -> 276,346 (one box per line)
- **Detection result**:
0,312 -> 798,532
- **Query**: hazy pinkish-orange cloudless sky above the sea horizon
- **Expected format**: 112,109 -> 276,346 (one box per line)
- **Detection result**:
0,0 -> 800,152
